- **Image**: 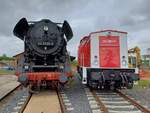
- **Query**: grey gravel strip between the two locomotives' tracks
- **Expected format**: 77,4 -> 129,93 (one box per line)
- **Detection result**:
63,73 -> 92,113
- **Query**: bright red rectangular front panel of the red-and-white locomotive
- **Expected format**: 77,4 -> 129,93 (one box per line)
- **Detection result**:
99,35 -> 120,68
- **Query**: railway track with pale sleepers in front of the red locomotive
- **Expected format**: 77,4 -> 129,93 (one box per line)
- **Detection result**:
86,89 -> 150,113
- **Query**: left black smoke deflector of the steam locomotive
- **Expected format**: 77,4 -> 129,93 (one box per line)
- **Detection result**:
13,18 -> 29,40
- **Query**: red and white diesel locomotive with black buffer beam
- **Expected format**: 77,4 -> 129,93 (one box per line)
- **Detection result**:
78,30 -> 139,89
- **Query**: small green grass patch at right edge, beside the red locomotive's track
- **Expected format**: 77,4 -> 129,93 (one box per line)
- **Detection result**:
134,80 -> 150,88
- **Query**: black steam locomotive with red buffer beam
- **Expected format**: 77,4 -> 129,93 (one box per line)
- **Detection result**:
13,18 -> 74,89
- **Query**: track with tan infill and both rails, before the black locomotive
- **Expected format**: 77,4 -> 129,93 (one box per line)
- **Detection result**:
19,90 -> 68,113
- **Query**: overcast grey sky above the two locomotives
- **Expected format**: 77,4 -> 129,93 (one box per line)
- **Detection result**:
0,0 -> 150,56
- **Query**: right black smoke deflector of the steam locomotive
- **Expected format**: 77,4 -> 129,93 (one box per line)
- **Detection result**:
62,21 -> 73,41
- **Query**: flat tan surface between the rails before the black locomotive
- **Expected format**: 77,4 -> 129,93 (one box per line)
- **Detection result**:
23,91 -> 61,113
